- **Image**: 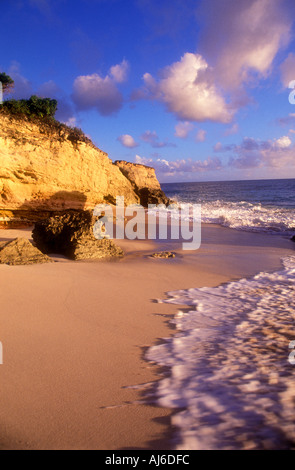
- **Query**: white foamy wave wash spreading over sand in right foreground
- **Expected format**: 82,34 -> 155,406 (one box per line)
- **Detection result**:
147,257 -> 295,450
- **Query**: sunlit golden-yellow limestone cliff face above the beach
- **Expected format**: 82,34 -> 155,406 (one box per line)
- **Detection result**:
0,113 -> 169,225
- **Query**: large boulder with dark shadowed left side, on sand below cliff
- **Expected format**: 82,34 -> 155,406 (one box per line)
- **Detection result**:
33,211 -> 124,260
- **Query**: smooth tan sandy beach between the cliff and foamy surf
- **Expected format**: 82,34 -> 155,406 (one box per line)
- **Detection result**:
0,225 -> 294,450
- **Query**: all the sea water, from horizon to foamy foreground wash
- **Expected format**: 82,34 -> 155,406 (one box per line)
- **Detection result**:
147,180 -> 295,450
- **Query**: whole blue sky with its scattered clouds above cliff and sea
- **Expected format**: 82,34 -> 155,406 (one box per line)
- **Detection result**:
0,0 -> 295,182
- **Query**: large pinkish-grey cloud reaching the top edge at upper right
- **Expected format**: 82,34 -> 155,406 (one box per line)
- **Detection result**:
198,0 -> 292,91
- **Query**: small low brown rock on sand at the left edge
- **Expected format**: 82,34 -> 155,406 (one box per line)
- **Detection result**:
0,238 -> 53,266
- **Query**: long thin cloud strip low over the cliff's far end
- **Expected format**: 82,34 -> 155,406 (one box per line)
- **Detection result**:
135,155 -> 223,176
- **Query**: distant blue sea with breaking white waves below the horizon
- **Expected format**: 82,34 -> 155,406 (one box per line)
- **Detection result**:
162,179 -> 295,236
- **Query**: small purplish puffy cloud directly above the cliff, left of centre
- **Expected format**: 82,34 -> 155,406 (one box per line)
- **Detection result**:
72,64 -> 128,116
